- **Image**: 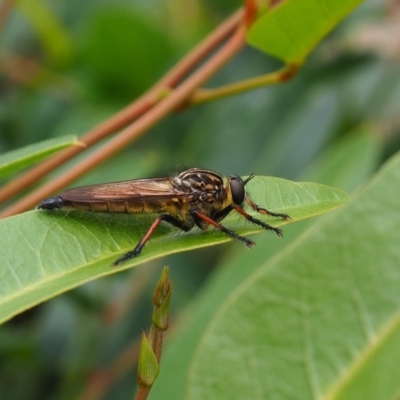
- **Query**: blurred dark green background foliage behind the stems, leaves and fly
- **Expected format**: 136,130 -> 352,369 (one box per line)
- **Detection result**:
0,0 -> 400,400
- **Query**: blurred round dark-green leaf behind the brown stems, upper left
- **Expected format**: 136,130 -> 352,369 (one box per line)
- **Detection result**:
82,7 -> 172,98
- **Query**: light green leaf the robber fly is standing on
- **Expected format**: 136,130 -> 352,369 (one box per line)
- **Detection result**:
0,177 -> 347,321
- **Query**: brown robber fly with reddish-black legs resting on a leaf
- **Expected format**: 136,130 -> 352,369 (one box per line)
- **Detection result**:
38,168 -> 290,266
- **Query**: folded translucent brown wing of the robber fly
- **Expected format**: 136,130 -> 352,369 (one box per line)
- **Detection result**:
60,178 -> 187,203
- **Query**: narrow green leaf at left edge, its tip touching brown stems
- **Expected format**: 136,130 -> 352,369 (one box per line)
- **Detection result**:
0,136 -> 83,178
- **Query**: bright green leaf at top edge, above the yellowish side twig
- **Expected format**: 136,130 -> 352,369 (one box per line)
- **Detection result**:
247,0 -> 362,64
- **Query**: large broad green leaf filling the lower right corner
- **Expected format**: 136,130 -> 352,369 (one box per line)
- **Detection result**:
187,156 -> 400,400
